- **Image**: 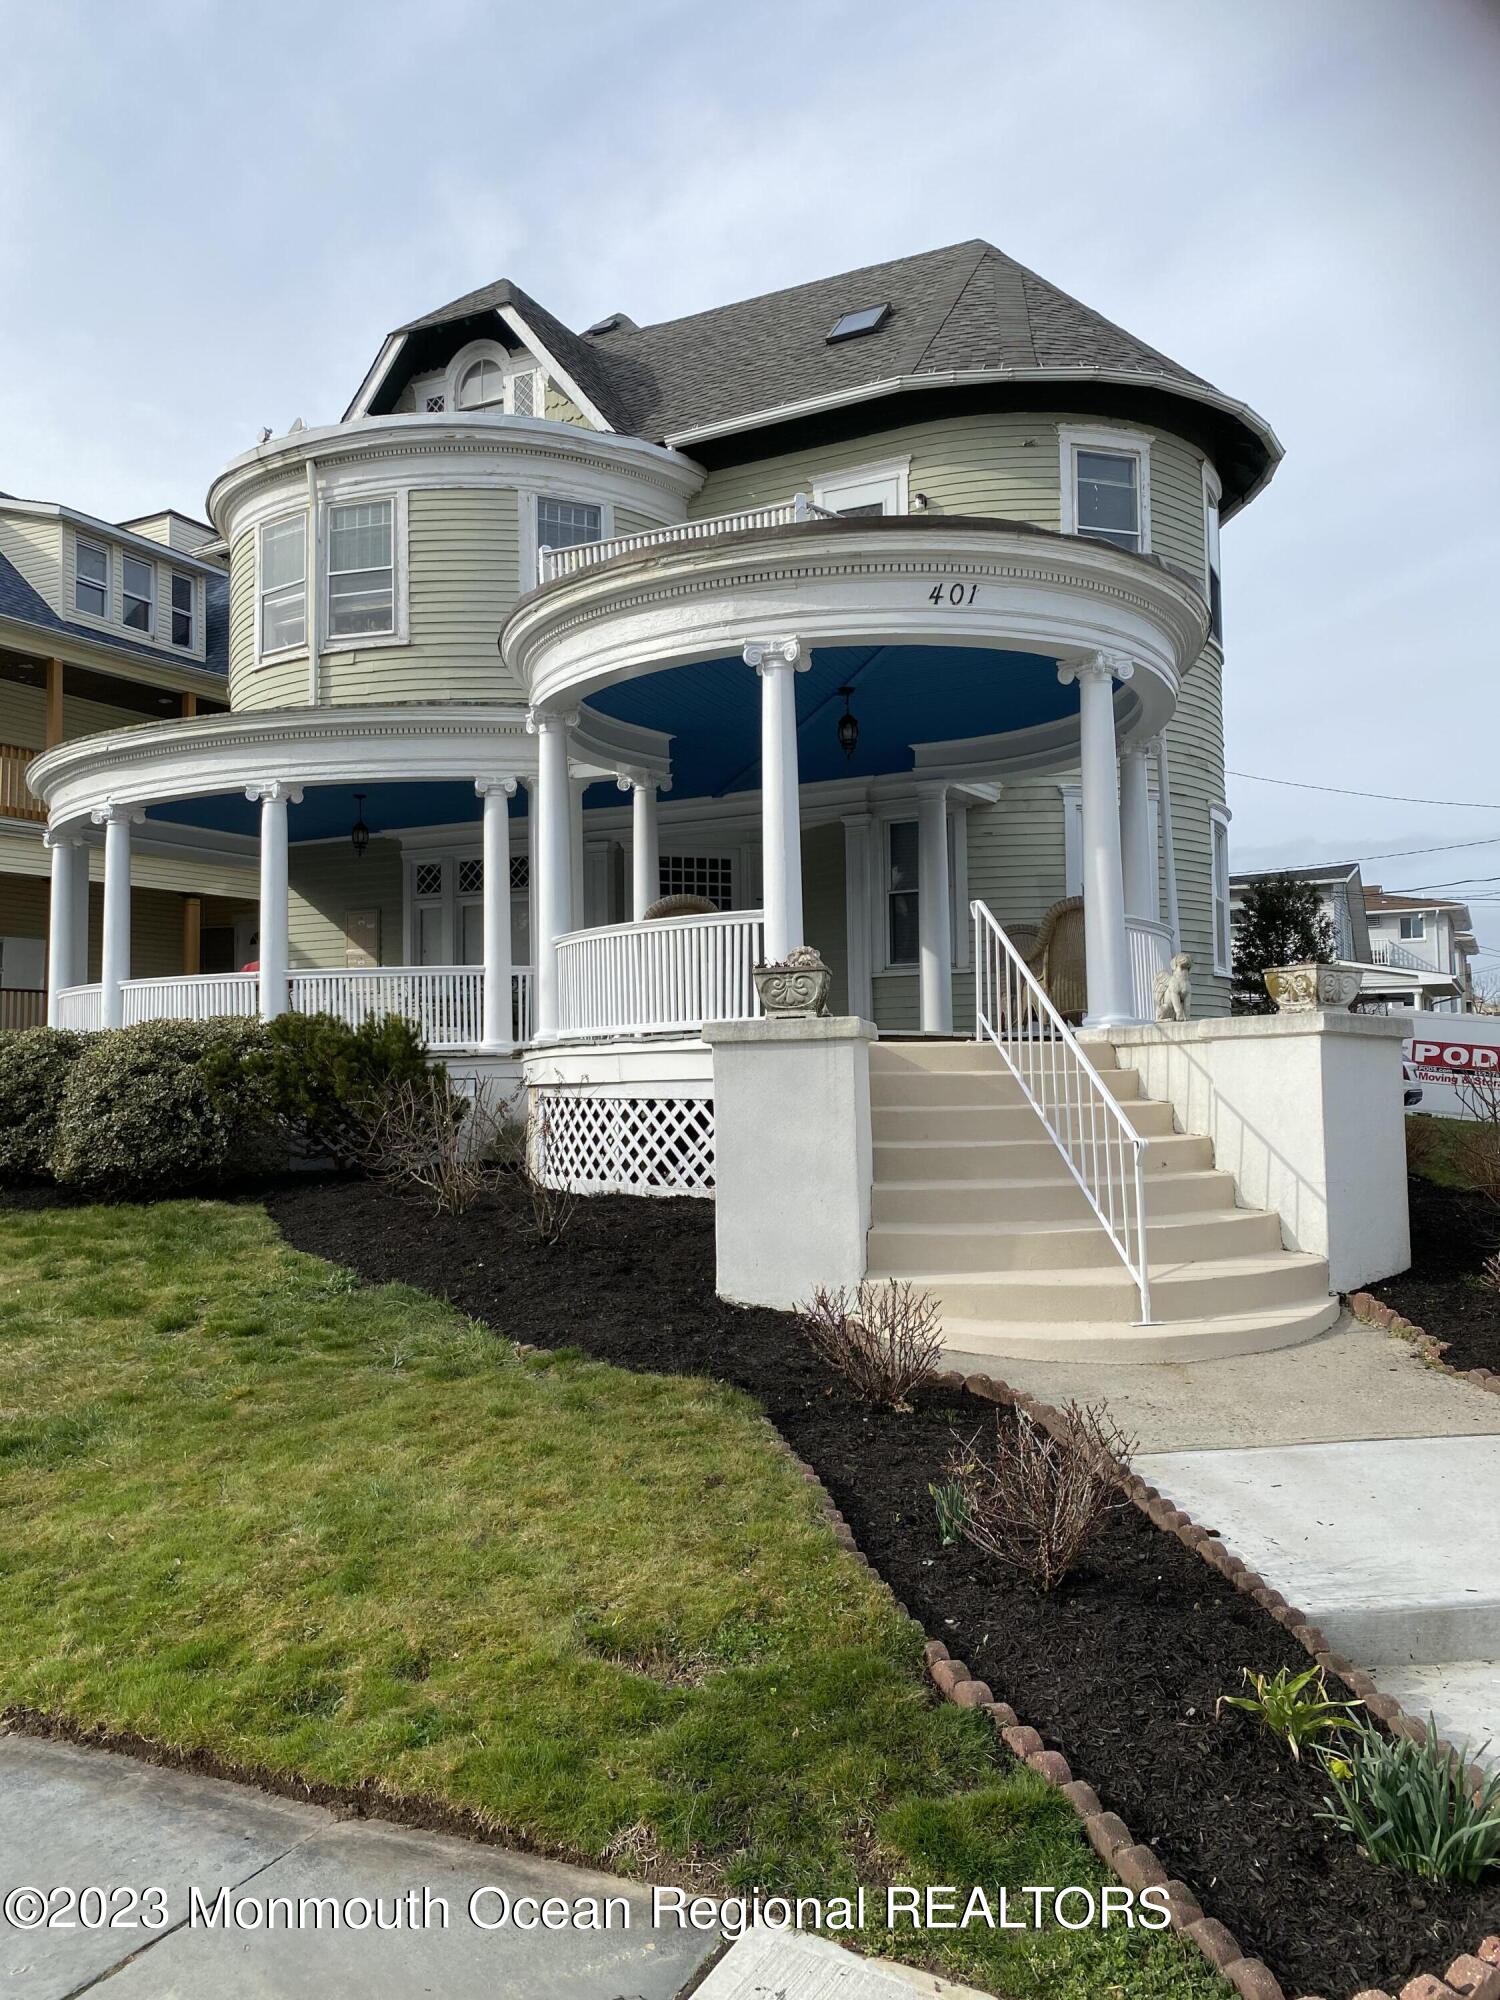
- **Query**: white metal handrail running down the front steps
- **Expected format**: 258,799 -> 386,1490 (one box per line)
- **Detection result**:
968,902 -> 1152,1324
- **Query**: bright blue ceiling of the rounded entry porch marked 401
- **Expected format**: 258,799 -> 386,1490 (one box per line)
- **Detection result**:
588,646 -> 1078,804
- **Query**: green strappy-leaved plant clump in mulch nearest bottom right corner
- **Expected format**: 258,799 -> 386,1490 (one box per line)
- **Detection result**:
1322,1722 -> 1500,1882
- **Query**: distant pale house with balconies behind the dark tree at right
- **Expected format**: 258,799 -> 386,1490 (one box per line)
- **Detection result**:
1230,862 -> 1478,1014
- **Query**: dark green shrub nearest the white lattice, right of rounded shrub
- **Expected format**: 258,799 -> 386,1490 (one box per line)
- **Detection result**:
254,1014 -> 430,1166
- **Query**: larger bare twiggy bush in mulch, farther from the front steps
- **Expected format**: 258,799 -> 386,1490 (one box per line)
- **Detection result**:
944,1402 -> 1136,1592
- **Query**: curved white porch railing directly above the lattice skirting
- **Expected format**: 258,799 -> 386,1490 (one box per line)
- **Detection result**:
558,910 -> 766,1036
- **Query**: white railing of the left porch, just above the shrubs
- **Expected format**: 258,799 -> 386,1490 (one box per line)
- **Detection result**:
58,966 -> 534,1052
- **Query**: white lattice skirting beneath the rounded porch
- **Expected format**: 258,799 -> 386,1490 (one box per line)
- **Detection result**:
532,1090 -> 714,1198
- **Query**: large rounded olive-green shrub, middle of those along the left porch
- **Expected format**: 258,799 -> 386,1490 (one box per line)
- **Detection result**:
52,1020 -> 286,1198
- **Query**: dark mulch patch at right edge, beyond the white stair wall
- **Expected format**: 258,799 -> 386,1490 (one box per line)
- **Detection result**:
1370,1174 -> 1500,1374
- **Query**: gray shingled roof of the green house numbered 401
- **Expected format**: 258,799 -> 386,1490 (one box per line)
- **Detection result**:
346,238 -> 1280,514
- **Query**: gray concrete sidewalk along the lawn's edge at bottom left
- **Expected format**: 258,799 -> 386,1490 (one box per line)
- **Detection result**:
0,1736 -> 720,2000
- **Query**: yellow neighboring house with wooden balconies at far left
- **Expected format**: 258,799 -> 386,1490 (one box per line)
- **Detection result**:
0,494 -> 256,1028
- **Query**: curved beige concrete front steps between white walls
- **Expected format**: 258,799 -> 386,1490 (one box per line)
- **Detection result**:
868,1042 -> 1338,1362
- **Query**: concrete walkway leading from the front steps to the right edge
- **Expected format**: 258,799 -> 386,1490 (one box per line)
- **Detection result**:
960,1316 -> 1500,1752
